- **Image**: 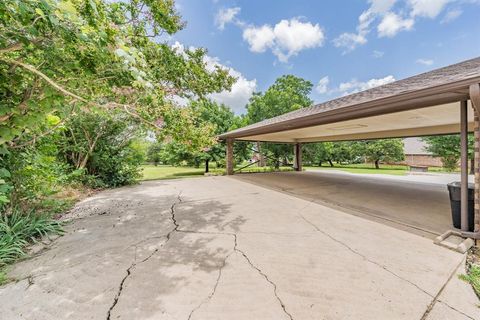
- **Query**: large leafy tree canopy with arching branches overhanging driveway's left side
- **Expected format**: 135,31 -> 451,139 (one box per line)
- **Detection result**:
0,0 -> 234,149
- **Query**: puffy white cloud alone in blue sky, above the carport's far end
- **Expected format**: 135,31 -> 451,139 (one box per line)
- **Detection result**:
243,18 -> 325,62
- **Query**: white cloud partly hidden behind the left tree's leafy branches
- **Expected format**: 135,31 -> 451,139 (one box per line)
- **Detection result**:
172,41 -> 257,114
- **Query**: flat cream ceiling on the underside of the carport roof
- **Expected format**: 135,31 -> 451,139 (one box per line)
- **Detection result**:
240,101 -> 473,142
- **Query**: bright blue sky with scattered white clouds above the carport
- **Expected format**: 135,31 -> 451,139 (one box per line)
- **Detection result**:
169,0 -> 480,113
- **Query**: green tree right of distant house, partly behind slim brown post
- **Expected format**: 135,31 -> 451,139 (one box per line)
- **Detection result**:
422,134 -> 474,173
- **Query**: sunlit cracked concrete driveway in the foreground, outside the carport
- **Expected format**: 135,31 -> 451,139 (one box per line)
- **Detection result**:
0,175 -> 480,320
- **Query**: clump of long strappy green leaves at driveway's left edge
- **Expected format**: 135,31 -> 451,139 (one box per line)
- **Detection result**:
0,210 -> 63,285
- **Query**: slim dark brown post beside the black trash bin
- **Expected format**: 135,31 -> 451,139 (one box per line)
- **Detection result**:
460,100 -> 469,231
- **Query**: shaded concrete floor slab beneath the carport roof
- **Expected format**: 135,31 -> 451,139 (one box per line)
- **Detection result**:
235,170 -> 460,239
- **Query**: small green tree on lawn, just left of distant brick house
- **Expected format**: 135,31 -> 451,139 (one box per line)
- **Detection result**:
357,139 -> 405,169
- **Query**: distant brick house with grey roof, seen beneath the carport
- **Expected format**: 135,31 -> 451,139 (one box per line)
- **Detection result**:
402,138 -> 442,167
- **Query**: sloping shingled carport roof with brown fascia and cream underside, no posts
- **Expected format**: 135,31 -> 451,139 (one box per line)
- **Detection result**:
219,57 -> 480,142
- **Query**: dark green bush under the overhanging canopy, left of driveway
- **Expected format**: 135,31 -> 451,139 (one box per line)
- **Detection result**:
59,113 -> 144,187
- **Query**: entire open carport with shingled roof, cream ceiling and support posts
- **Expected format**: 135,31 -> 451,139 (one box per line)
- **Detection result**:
220,57 -> 480,239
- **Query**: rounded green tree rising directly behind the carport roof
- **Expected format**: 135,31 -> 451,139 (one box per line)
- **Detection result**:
247,75 -> 313,167
